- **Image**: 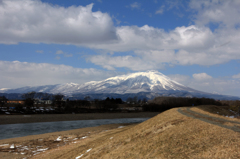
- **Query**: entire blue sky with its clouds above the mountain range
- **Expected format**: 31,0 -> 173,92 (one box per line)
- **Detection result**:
0,0 -> 240,96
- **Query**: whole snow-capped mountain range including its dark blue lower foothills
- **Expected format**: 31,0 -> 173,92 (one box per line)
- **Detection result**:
0,71 -> 239,99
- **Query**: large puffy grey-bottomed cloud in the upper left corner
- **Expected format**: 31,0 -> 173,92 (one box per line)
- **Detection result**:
0,0 -> 117,45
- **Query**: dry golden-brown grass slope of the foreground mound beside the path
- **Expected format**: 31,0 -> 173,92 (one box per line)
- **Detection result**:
1,106 -> 240,159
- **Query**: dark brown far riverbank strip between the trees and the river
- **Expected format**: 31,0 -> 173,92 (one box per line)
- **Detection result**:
0,112 -> 159,125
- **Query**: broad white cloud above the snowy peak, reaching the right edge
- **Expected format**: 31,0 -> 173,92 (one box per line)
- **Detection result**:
88,25 -> 240,70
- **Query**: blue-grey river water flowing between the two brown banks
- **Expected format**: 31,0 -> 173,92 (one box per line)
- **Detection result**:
0,118 -> 149,140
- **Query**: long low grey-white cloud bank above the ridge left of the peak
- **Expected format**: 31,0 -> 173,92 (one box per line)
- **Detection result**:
0,61 -> 117,88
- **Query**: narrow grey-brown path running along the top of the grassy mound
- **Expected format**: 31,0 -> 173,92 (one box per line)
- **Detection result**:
178,108 -> 240,133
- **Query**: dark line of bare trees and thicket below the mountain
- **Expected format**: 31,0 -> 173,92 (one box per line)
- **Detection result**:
0,92 -> 240,114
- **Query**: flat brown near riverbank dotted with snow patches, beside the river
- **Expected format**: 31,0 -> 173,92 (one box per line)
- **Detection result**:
0,124 -> 137,159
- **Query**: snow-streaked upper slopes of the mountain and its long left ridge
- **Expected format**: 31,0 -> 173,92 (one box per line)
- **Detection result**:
1,71 -> 196,95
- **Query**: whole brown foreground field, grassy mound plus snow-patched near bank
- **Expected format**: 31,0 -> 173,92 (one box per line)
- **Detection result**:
0,106 -> 240,159
